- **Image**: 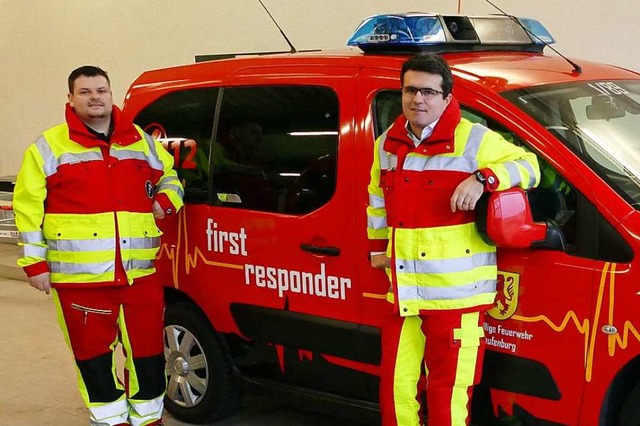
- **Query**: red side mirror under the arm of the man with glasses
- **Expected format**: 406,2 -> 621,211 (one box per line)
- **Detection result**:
476,188 -> 565,250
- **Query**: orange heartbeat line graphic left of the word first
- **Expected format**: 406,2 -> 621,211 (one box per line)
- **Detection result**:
156,205 -> 244,288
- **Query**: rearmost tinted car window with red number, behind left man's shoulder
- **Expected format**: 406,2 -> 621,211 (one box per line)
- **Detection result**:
134,88 -> 219,203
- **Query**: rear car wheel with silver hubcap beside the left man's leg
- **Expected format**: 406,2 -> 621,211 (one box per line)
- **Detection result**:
164,302 -> 240,423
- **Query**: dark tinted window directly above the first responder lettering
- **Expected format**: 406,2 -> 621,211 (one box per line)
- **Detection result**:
212,86 -> 338,215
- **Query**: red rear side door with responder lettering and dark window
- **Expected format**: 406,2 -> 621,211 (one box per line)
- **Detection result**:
203,66 -> 376,396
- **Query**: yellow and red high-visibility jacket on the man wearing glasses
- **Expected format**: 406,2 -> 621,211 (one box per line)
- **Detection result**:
367,99 -> 540,316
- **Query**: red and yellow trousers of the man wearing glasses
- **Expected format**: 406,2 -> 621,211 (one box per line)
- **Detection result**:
380,311 -> 485,426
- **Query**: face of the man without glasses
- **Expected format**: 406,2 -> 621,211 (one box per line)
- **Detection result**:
67,75 -> 113,122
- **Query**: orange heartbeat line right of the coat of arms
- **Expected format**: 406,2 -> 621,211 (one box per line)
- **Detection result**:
512,262 -> 640,382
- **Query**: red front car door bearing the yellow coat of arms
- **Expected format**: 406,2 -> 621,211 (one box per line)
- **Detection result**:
456,87 -> 617,424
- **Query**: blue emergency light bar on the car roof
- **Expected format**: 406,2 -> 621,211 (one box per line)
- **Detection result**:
347,13 -> 555,52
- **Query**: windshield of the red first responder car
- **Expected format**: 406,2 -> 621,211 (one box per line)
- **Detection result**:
503,80 -> 640,209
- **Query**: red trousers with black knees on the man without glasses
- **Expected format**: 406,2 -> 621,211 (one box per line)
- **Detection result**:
53,276 -> 166,425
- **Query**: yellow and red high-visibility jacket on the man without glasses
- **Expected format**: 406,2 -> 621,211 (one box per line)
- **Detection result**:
13,104 -> 183,285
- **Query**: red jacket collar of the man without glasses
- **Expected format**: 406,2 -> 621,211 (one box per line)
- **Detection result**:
65,103 -> 142,148
